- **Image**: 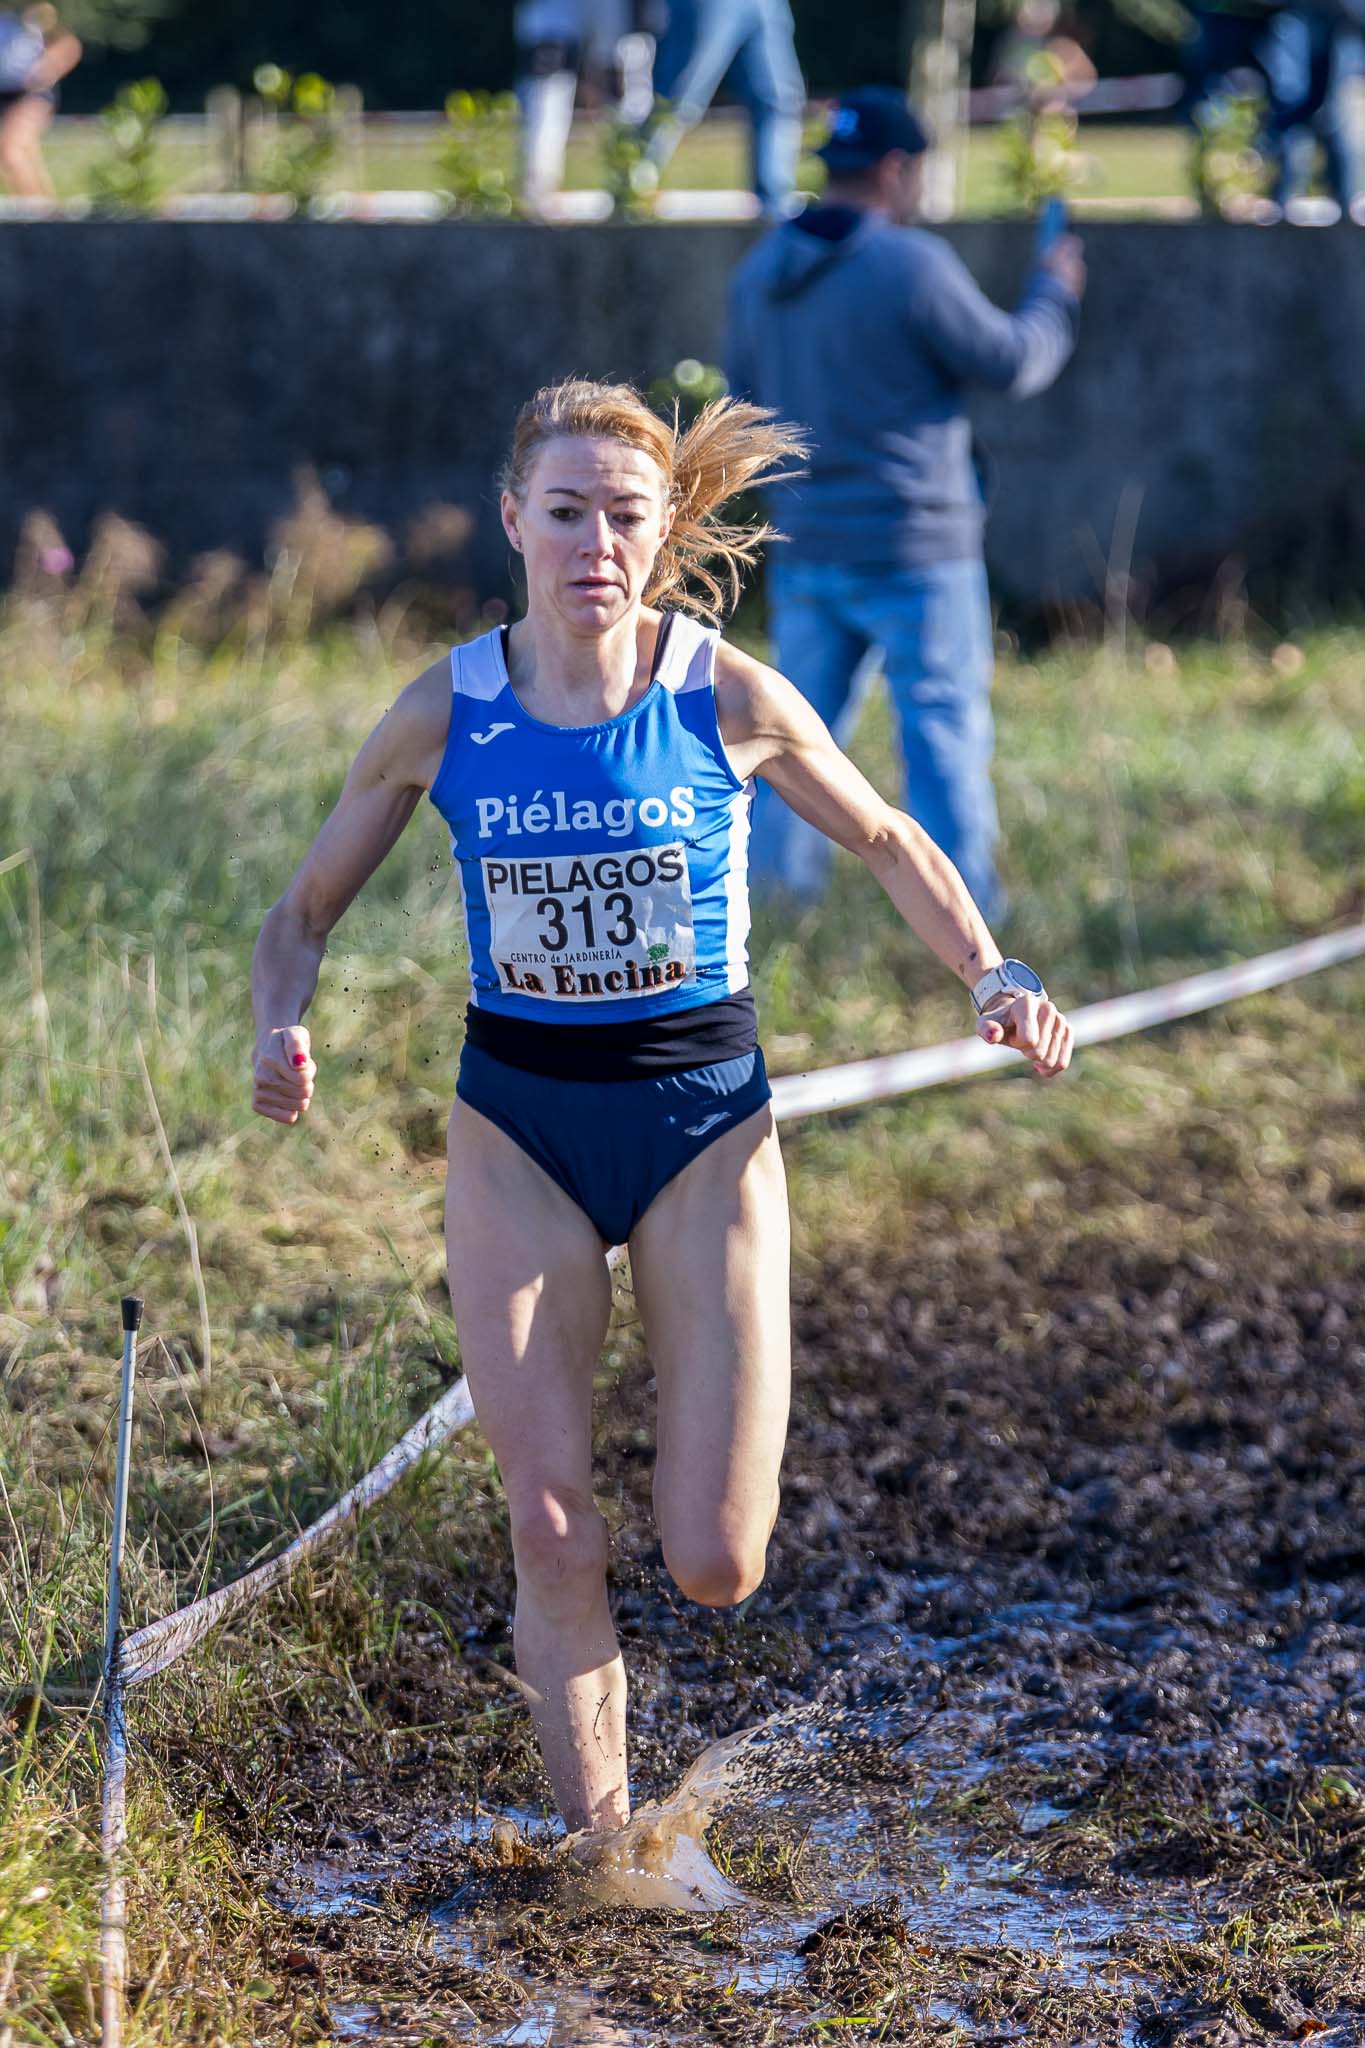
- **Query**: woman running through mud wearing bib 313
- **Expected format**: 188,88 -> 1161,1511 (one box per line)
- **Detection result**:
252,381 -> 1072,1829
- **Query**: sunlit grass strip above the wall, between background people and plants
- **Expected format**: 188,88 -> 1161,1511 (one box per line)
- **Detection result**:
37,117 -> 1189,215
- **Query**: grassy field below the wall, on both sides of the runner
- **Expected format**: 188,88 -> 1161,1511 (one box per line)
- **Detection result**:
0,608 -> 1365,2044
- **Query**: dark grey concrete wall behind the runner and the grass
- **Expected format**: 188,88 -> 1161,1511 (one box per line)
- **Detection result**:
0,221 -> 1365,606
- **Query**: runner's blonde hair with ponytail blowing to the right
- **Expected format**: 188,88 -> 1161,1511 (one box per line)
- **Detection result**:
499,377 -> 806,625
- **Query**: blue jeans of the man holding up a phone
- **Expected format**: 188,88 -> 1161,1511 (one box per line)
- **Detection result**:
749,555 -> 1005,918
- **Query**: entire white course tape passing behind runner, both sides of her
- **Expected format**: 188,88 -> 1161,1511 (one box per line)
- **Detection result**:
121,924 -> 1365,1686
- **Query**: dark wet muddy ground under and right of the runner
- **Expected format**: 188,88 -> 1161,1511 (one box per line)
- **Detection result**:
227,1210 -> 1365,2048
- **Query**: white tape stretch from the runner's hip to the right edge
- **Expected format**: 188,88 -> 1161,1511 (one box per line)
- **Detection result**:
774,924 -> 1365,1122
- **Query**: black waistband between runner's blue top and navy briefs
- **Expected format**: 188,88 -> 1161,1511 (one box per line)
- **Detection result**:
465,989 -> 759,1081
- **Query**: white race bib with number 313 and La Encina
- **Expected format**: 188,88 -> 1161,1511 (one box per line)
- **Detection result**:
481,844 -> 696,1004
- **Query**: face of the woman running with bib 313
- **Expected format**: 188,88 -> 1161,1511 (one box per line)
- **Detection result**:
501,434 -> 673,633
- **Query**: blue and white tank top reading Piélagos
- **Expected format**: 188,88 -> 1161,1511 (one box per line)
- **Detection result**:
432,612 -> 753,1024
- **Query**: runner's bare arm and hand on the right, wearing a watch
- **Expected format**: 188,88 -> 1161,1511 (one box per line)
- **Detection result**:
716,645 -> 1072,1077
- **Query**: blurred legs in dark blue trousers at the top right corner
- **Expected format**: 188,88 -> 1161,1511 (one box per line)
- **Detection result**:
1265,0 -> 1365,227
